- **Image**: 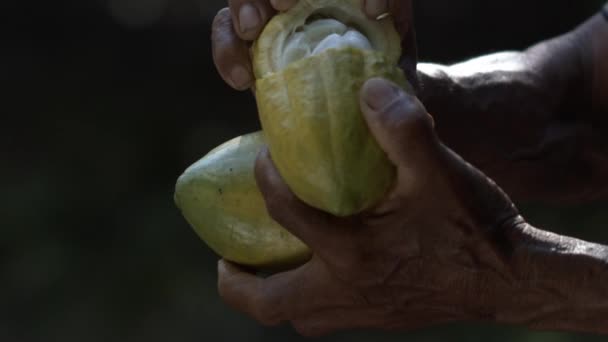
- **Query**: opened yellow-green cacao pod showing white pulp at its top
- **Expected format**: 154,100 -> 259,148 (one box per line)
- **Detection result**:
253,0 -> 408,216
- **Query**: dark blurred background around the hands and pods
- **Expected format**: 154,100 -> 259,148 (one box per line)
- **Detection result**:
0,0 -> 608,342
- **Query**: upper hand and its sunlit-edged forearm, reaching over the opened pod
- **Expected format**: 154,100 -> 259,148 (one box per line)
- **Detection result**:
212,0 -> 608,202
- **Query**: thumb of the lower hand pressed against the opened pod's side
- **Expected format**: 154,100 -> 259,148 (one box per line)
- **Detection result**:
360,78 -> 440,167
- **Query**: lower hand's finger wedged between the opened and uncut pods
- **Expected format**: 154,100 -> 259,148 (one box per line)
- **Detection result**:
255,148 -> 348,258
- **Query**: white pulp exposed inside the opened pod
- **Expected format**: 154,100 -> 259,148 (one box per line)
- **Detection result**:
279,19 -> 372,69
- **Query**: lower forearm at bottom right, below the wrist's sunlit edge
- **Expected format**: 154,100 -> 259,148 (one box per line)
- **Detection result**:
496,225 -> 608,334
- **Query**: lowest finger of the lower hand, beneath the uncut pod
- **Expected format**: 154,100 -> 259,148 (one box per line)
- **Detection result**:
218,259 -> 346,326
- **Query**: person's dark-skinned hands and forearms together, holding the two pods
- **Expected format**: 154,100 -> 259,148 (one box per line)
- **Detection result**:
212,0 -> 608,336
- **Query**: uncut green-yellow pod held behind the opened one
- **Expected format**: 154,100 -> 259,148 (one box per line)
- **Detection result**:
175,132 -> 310,270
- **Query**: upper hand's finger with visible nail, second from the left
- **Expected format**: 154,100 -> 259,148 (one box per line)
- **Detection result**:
228,0 -> 276,41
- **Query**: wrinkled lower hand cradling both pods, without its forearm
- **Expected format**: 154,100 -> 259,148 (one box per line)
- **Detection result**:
219,79 -> 520,335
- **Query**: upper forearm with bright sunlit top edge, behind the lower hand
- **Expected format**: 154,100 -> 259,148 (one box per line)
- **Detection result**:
419,10 -> 608,201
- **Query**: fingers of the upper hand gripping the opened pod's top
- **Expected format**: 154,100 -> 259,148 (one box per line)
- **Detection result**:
211,0 -> 417,90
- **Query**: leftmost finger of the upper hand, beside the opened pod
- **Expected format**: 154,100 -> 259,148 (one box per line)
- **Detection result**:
211,8 -> 253,90
